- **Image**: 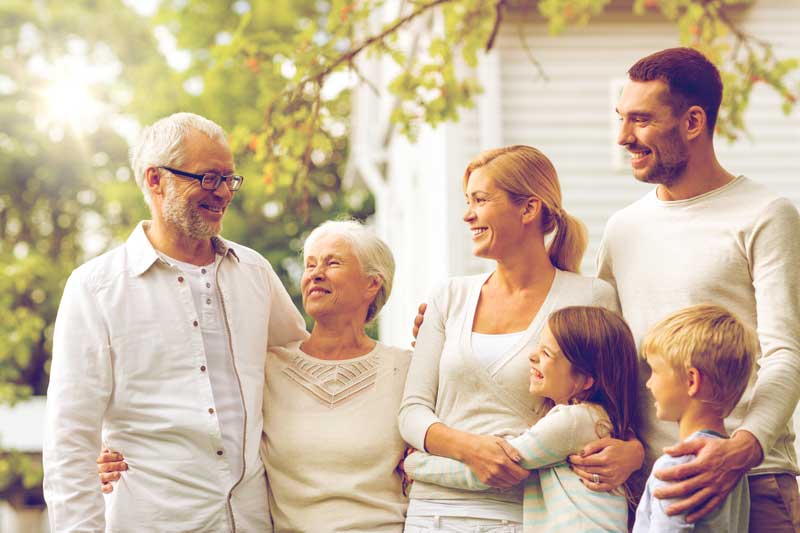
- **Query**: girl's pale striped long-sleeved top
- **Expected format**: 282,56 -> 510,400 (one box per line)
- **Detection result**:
405,403 -> 628,533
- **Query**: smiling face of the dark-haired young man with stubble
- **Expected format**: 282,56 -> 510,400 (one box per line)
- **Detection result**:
617,80 -> 689,186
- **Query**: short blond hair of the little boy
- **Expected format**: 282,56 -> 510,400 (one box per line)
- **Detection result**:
642,304 -> 758,418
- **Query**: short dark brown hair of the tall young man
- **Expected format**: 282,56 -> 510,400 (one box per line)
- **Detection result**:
628,48 -> 722,136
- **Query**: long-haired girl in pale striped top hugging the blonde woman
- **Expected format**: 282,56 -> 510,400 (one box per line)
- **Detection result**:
404,307 -> 638,533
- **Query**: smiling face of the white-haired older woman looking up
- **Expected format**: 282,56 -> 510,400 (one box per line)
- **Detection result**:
300,234 -> 380,323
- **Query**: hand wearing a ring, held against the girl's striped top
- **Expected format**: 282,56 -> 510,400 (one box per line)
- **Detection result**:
569,437 -> 644,492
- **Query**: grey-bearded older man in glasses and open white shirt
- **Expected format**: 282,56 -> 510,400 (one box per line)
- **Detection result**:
43,113 -> 307,532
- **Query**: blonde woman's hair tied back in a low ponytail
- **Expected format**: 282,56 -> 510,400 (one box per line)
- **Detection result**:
463,145 -> 587,272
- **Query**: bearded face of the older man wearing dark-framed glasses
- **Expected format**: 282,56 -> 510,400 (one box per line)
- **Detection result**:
154,130 -> 234,240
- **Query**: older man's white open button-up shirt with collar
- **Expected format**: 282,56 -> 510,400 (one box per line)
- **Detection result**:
43,224 -> 307,532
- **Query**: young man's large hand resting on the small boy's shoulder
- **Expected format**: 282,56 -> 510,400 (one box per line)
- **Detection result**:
653,431 -> 763,523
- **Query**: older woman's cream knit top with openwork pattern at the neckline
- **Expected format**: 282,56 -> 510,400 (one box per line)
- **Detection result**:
262,343 -> 411,533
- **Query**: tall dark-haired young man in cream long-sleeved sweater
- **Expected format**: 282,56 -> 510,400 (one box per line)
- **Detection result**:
598,48 -> 800,532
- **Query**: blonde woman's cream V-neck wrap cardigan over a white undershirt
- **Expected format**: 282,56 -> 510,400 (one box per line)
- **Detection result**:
399,270 -> 616,504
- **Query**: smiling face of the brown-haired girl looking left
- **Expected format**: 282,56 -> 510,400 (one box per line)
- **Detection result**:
528,326 -> 592,404
